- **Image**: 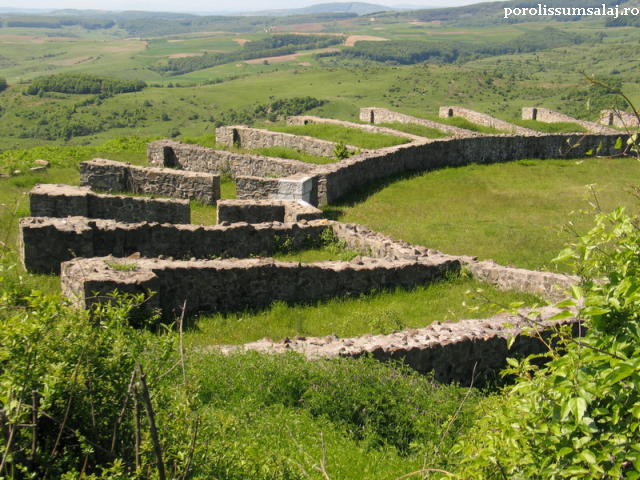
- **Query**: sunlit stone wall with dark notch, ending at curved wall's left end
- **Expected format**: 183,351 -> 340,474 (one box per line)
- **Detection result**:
147,140 -> 315,178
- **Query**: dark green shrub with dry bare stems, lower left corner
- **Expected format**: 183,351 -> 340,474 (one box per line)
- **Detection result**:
0,272 -> 198,478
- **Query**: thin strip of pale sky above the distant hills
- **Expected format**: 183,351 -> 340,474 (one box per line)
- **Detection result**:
0,0 -> 486,13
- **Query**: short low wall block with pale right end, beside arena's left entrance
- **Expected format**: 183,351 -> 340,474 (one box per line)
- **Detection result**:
217,200 -> 322,223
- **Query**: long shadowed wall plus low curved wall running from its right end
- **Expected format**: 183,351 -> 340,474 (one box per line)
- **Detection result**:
20,217 -> 577,299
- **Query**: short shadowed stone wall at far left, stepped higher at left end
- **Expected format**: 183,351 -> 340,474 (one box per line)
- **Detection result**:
29,184 -> 191,223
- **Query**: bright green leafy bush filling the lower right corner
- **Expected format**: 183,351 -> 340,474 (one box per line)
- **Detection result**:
455,202 -> 640,479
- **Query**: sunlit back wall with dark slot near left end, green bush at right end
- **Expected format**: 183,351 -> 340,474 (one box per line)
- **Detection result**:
216,125 -> 358,158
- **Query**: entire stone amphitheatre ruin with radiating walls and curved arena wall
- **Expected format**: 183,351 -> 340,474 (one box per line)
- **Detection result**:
20,107 -> 620,384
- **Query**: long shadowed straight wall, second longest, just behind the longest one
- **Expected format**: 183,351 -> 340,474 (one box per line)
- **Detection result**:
20,217 -> 330,273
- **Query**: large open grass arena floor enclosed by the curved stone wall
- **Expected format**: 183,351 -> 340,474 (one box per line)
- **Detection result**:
324,158 -> 638,270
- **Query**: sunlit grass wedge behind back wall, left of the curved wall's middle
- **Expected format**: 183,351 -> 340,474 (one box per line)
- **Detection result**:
270,123 -> 409,149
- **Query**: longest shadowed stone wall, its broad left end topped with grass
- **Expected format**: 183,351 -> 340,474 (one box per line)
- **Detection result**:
61,257 -> 456,317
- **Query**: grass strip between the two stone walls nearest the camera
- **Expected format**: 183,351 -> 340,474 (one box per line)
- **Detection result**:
185,277 -> 539,347
